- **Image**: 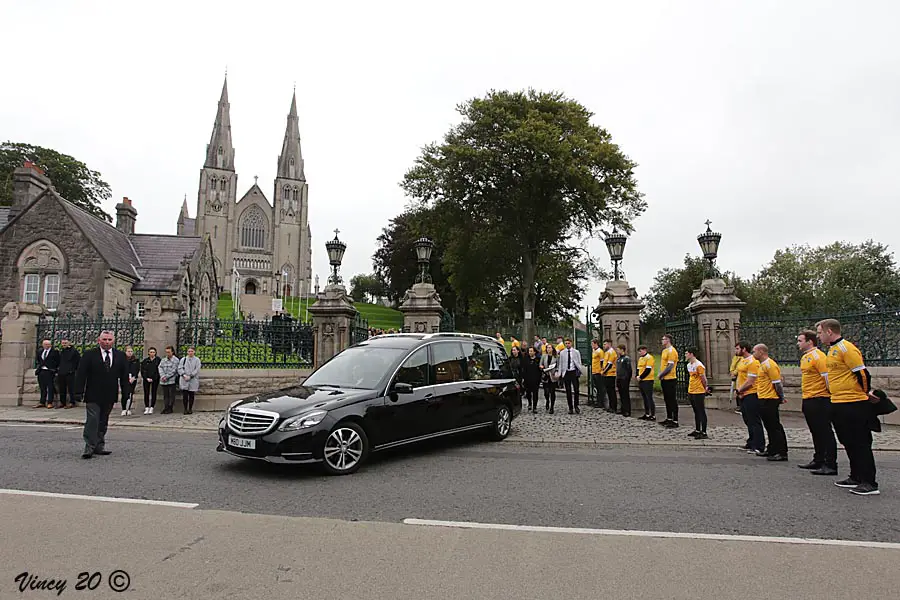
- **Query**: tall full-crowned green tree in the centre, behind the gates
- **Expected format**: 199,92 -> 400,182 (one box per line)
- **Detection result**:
402,90 -> 645,338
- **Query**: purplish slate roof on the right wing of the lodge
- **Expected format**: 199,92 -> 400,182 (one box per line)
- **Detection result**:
130,233 -> 202,291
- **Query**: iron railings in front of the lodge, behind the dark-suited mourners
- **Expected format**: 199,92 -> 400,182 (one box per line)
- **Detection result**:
35,313 -> 144,361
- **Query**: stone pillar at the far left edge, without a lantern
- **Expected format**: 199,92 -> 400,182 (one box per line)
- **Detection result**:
0,302 -> 44,406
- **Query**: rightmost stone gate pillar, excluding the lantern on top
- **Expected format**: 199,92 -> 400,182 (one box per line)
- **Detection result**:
678,279 -> 746,407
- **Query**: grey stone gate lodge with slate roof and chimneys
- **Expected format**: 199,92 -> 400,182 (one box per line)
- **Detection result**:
0,163 -> 219,318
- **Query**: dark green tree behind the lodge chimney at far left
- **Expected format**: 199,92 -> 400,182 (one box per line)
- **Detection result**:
0,142 -> 112,223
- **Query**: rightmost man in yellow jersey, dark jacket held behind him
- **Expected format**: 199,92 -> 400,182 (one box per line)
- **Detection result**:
816,319 -> 881,496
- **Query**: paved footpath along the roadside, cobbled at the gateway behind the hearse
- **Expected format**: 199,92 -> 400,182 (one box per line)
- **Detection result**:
0,405 -> 900,451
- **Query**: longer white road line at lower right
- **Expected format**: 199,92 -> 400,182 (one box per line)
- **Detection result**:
403,519 -> 900,550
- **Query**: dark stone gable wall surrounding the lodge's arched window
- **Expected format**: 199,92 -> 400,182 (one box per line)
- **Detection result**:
0,194 -> 106,314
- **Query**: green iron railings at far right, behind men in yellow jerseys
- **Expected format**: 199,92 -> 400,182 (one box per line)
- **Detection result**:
739,309 -> 900,367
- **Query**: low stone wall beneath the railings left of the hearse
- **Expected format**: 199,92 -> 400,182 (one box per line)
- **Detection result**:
22,368 -> 312,413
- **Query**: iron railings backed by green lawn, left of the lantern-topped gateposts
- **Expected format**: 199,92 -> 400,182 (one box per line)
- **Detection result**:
176,316 -> 314,369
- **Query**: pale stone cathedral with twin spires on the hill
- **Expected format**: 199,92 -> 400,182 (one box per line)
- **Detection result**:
178,77 -> 312,297
